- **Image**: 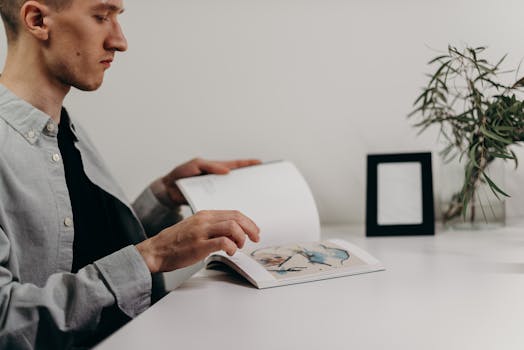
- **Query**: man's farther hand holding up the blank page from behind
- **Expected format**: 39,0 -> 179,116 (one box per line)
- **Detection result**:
161,158 -> 261,205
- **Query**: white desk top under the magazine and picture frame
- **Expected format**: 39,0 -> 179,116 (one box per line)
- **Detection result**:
99,223 -> 524,350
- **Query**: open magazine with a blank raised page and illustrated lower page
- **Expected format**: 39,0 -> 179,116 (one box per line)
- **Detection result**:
177,161 -> 384,288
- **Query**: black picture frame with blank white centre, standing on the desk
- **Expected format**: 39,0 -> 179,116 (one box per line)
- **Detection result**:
366,152 -> 435,237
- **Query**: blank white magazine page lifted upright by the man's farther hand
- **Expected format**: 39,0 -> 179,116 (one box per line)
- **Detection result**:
177,161 -> 320,249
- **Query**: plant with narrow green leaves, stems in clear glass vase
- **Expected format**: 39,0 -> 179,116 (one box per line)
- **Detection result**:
409,46 -> 524,227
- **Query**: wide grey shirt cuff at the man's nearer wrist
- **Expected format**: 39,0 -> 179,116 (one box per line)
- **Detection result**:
94,245 -> 152,317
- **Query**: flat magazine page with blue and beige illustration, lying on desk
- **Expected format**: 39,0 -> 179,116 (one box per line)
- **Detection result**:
209,240 -> 384,288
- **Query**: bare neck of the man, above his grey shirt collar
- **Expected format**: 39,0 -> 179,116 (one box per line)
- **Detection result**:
0,38 -> 71,124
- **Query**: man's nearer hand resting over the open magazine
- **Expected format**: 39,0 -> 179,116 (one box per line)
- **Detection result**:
136,210 -> 260,273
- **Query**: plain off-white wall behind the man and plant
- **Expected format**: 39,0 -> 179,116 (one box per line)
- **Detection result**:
0,0 -> 524,223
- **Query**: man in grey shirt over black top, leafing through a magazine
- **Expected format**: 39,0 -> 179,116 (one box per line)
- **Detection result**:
0,0 -> 259,349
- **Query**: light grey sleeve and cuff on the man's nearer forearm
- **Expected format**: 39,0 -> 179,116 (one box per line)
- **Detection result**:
0,227 -> 151,349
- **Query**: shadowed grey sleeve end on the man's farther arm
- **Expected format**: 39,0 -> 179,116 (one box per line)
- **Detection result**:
133,186 -> 182,237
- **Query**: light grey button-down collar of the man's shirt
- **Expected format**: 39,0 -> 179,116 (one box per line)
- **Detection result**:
0,84 -> 76,144
